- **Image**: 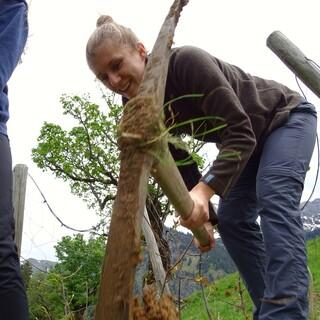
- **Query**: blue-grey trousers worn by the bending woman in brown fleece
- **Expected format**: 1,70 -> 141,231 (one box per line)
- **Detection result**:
218,102 -> 317,320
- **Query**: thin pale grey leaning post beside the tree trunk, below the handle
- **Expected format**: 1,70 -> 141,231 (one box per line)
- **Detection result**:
142,208 -> 170,295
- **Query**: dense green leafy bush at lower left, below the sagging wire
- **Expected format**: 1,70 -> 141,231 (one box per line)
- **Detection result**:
27,234 -> 105,320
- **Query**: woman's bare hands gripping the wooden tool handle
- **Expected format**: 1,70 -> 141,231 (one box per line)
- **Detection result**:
180,182 -> 214,252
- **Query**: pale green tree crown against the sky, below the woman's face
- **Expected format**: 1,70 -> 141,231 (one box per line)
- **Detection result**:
32,95 -> 121,218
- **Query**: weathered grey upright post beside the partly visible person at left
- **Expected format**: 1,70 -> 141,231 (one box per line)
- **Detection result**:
12,164 -> 28,256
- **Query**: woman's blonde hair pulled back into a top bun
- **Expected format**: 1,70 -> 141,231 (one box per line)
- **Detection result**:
86,15 -> 139,62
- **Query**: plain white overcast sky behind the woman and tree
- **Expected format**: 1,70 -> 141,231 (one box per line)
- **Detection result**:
8,0 -> 320,260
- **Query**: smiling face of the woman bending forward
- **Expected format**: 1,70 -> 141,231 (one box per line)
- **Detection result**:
89,40 -> 147,99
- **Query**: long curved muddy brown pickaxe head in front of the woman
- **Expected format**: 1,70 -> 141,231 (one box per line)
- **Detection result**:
95,0 -> 191,320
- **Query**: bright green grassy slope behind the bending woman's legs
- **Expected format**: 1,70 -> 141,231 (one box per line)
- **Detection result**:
181,238 -> 320,320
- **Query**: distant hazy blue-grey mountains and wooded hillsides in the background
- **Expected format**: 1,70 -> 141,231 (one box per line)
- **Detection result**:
28,199 -> 320,298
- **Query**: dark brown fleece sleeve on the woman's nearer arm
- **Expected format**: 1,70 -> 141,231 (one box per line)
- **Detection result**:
171,47 -> 256,198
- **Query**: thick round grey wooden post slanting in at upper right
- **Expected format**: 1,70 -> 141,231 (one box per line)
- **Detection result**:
267,31 -> 320,98
